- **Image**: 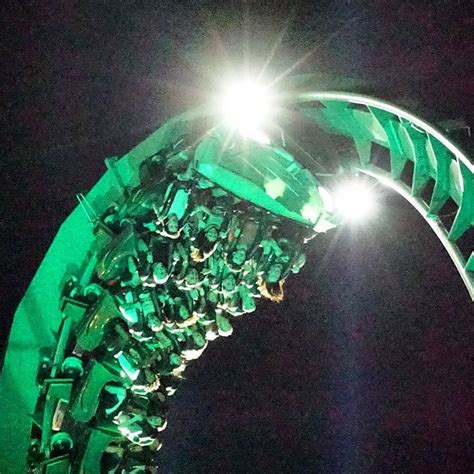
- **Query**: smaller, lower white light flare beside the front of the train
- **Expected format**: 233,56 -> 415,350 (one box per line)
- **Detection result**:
334,181 -> 377,222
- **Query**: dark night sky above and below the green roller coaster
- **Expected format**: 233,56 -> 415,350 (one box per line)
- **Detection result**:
0,0 -> 474,473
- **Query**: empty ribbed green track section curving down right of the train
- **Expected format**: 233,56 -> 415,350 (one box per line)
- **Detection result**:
294,92 -> 474,299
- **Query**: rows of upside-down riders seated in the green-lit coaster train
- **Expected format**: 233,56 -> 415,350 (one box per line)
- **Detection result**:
65,146 -> 307,472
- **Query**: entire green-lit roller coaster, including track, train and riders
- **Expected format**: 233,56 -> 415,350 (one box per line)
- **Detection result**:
0,92 -> 474,474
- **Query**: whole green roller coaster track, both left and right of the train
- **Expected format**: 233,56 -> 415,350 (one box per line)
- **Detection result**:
0,92 -> 474,473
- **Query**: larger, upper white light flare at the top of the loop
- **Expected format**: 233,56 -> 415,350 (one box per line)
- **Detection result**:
219,80 -> 274,143
